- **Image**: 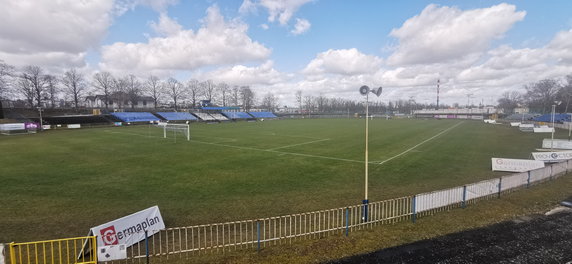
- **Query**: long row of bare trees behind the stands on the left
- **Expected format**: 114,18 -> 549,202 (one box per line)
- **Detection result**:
0,60 -> 256,110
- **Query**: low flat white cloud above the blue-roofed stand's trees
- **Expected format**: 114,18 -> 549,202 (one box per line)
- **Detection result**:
194,60 -> 291,85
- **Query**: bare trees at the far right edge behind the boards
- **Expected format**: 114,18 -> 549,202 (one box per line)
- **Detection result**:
498,74 -> 572,113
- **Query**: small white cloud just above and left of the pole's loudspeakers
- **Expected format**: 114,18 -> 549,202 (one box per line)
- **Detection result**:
302,48 -> 382,75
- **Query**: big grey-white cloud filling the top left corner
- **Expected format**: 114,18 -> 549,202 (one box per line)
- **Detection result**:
0,0 -> 113,67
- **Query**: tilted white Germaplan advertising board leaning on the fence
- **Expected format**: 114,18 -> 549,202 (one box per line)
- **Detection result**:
89,206 -> 165,247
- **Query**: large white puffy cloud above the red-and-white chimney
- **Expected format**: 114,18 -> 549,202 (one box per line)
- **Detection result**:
388,3 -> 526,65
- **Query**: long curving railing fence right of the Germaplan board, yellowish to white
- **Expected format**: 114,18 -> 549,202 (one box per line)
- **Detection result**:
1,161 -> 569,264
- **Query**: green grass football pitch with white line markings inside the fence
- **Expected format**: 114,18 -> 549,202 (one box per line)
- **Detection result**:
0,119 -> 556,242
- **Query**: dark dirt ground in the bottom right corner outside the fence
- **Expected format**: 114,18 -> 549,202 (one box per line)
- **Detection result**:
331,197 -> 572,264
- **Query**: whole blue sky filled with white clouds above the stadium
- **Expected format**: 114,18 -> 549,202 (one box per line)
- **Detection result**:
0,0 -> 572,105
